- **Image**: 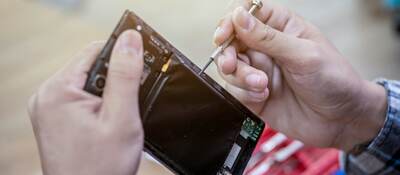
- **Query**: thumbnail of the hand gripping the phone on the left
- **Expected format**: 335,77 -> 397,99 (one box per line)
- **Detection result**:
117,31 -> 139,55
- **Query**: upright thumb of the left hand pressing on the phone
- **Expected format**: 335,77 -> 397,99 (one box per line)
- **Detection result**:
103,30 -> 143,118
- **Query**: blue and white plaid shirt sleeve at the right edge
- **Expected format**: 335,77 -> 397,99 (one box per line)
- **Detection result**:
345,79 -> 400,175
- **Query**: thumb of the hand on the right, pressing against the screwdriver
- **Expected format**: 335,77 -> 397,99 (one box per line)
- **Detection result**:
232,7 -> 314,66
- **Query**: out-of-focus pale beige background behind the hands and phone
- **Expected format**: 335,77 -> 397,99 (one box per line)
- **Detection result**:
0,0 -> 400,175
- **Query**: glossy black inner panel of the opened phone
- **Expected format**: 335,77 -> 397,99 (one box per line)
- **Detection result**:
143,57 -> 245,174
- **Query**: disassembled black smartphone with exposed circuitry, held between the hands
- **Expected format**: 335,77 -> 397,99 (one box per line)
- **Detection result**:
84,11 -> 264,175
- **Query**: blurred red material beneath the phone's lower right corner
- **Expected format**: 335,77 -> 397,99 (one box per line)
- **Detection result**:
245,128 -> 339,175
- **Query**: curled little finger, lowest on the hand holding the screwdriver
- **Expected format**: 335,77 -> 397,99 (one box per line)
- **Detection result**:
225,83 -> 269,105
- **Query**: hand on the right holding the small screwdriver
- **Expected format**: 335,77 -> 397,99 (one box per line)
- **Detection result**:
215,0 -> 387,150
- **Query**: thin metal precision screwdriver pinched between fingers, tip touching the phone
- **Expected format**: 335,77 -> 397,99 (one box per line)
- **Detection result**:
199,0 -> 263,75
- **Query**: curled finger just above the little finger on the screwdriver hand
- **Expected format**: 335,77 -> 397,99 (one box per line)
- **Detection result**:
220,60 -> 268,92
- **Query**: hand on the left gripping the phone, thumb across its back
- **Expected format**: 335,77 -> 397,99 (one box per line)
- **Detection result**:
28,31 -> 143,175
